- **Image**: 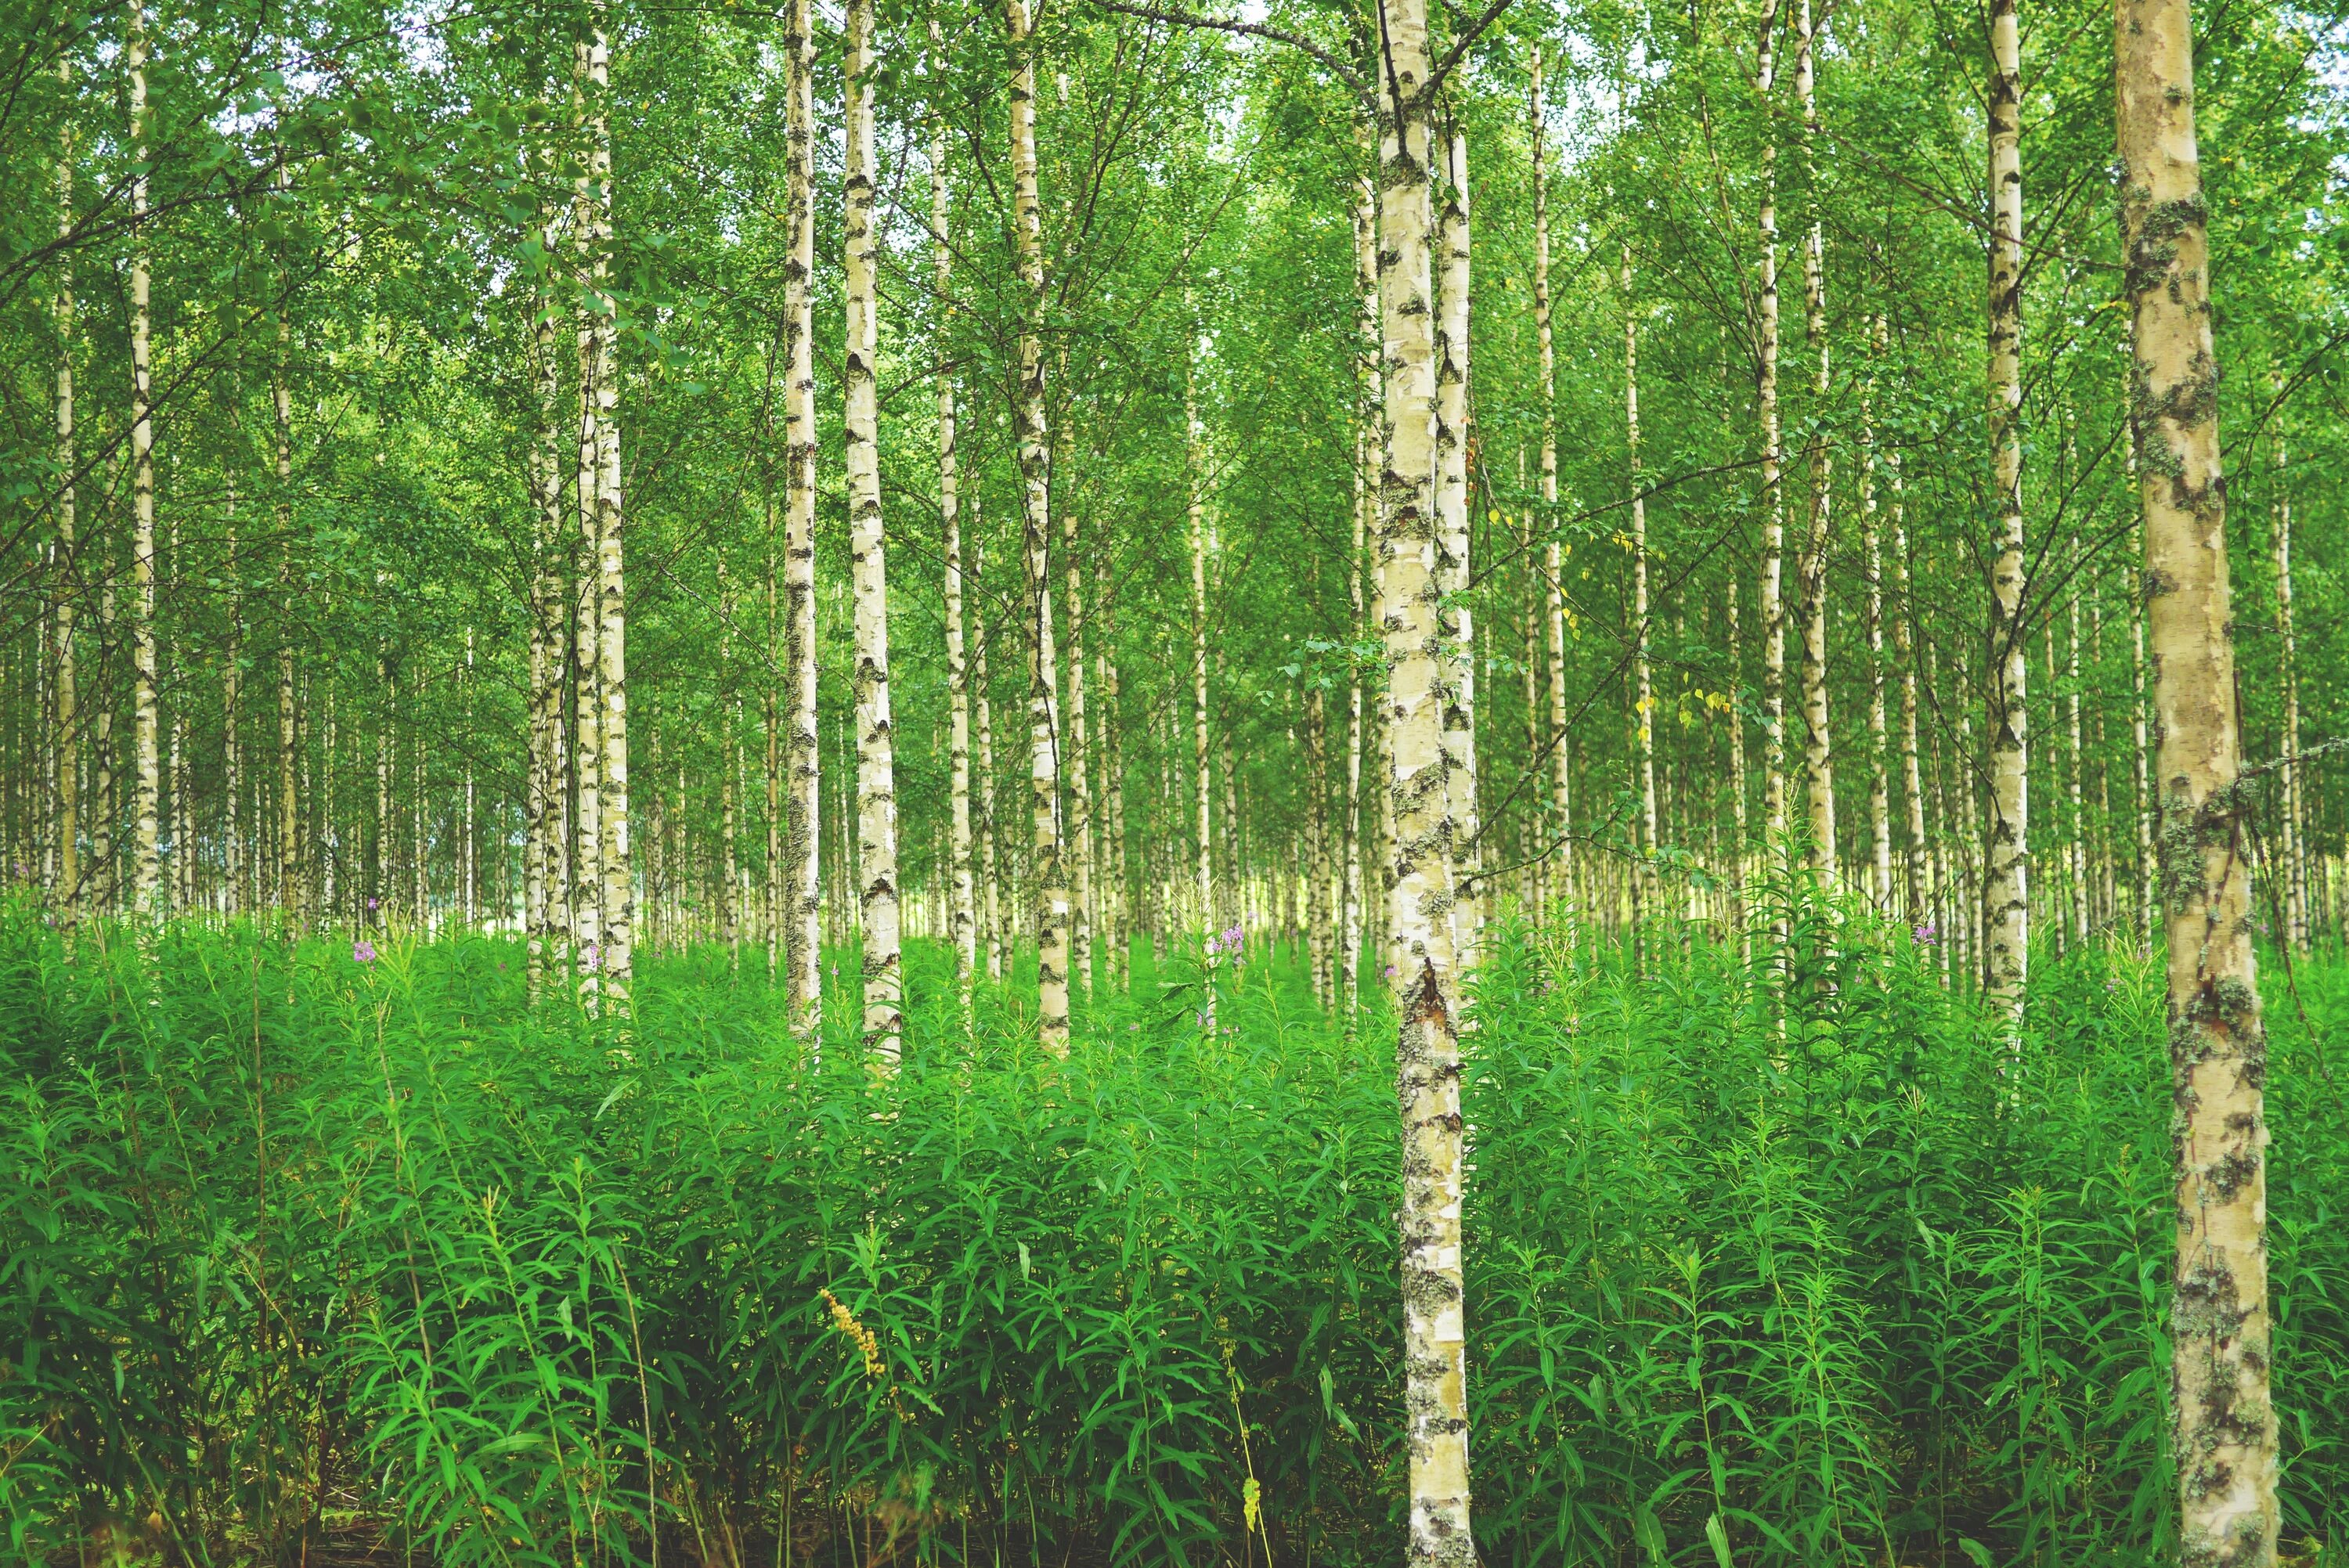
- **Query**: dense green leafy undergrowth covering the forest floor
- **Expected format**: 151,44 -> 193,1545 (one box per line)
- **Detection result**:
0,892 -> 2349,1568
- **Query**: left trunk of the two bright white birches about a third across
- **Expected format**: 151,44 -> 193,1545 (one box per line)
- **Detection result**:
782,0 -> 824,1018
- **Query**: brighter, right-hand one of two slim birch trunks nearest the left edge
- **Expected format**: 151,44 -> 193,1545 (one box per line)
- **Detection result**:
122,0 -> 162,920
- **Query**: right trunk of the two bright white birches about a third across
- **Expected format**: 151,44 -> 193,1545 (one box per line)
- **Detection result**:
841,0 -> 904,1070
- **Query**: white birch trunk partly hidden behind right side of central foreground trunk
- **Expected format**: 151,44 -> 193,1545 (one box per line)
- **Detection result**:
1435,127 -> 1485,969
